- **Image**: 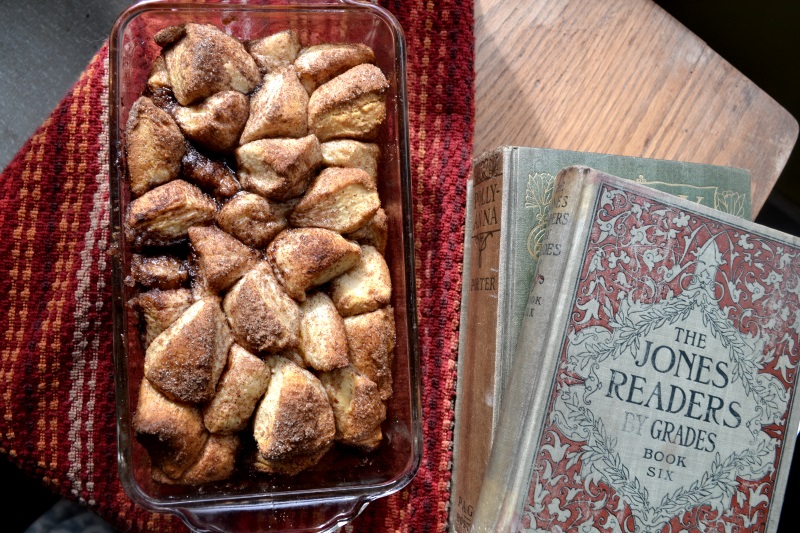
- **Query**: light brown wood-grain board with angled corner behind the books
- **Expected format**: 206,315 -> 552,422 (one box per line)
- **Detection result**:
474,0 -> 798,216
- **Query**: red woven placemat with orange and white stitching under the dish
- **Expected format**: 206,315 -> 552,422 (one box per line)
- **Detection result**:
0,0 -> 474,531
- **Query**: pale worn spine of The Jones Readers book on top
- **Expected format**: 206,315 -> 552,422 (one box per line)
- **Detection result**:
472,167 -> 594,531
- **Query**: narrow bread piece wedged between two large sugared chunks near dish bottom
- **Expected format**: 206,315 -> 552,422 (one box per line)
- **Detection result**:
203,344 -> 270,433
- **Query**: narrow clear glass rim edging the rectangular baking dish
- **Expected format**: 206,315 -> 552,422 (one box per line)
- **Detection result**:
108,0 -> 422,516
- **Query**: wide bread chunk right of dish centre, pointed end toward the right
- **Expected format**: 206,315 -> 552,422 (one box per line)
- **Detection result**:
267,228 -> 361,302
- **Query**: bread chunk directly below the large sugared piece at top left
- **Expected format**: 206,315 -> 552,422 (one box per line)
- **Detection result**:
172,91 -> 250,152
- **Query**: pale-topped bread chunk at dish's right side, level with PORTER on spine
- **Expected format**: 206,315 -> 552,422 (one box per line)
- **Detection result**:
331,246 -> 392,317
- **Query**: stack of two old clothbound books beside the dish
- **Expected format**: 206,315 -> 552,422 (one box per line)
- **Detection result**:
450,147 -> 800,532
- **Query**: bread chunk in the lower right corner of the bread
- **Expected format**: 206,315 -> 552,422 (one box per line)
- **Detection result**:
320,366 -> 386,448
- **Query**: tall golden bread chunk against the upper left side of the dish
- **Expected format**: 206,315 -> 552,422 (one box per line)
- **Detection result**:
125,96 -> 185,196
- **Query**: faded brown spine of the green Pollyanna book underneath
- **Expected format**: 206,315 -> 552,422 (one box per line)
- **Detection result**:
450,149 -> 504,533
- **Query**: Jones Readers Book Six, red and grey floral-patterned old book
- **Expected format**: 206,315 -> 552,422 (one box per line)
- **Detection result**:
473,167 -> 800,532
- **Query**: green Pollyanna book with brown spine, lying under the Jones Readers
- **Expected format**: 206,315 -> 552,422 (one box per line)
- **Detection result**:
450,146 -> 750,532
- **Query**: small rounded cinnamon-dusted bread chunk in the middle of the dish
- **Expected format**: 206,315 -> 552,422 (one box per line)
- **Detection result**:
217,192 -> 288,248
